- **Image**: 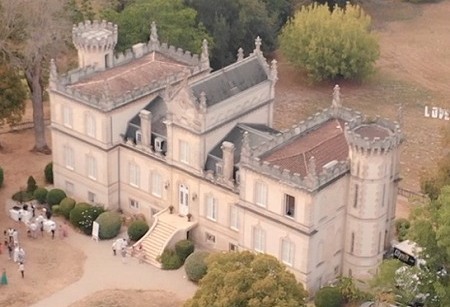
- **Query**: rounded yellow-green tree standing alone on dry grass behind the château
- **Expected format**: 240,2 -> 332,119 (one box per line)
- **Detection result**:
279,4 -> 379,81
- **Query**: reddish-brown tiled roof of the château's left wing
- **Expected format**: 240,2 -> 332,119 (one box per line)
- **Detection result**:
67,52 -> 189,98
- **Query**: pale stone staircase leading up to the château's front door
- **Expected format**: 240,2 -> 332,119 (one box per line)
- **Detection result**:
137,220 -> 178,268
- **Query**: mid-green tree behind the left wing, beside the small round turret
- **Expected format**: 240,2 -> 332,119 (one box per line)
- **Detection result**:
102,0 -> 212,53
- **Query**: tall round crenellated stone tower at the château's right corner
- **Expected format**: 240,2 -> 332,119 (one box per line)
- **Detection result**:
342,114 -> 403,278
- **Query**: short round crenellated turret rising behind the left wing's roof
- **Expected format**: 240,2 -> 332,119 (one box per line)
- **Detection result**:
72,20 -> 117,71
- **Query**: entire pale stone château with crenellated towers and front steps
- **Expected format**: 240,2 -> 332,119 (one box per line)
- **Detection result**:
49,21 -> 403,292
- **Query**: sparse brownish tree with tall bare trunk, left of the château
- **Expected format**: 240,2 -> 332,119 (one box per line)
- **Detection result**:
0,0 -> 71,154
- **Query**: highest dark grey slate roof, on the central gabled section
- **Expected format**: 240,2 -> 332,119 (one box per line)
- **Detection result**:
191,56 -> 268,106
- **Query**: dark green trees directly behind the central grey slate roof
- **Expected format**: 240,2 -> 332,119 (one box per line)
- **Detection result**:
186,0 -> 278,69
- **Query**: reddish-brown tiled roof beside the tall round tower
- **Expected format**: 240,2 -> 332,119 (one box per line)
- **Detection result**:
260,119 -> 348,176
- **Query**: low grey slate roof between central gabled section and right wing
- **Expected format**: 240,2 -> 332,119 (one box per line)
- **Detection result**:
205,123 -> 280,171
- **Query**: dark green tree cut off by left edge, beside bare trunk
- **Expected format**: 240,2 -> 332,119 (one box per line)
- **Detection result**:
0,61 -> 26,147
